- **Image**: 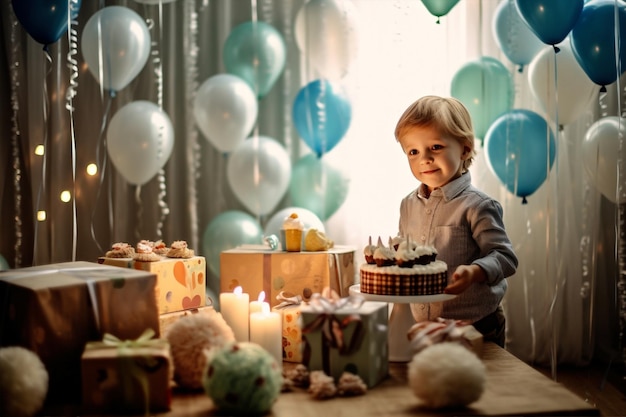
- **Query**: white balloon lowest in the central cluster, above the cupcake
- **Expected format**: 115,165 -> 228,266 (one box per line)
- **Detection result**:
226,136 -> 291,215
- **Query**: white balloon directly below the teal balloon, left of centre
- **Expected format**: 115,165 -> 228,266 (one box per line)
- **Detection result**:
193,74 -> 259,153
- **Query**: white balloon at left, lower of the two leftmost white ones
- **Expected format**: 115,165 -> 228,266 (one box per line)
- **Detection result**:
107,100 -> 174,185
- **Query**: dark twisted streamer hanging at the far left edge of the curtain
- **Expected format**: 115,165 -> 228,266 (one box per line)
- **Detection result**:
9,13 -> 22,268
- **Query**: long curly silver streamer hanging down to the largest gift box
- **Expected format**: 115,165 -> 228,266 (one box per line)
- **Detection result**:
65,0 -> 78,261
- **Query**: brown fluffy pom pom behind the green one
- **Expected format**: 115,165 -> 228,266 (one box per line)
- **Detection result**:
166,309 -> 235,390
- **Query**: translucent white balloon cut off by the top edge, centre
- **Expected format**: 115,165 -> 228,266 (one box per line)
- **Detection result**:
294,0 -> 358,80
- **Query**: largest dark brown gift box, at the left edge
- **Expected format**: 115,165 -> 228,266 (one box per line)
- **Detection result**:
0,262 -> 159,403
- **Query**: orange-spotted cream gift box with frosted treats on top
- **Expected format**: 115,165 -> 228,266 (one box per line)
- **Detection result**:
98,256 -> 206,314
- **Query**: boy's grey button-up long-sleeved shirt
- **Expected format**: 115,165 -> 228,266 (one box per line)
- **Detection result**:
399,172 -> 518,322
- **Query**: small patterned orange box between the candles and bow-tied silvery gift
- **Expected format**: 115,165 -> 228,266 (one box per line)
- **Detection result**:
272,293 -> 302,363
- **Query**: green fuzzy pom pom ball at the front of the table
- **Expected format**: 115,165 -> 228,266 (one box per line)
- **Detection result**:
204,342 -> 283,415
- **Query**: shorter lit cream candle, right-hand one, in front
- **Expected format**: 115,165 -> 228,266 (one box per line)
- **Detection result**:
250,303 -> 283,367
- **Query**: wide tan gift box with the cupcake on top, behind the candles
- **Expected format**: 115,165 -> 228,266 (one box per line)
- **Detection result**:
220,246 -> 355,307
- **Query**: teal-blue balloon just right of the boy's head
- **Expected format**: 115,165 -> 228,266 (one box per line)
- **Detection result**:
485,109 -> 556,203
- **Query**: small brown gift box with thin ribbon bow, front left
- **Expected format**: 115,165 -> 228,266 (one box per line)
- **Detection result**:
81,332 -> 173,415
